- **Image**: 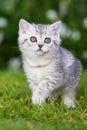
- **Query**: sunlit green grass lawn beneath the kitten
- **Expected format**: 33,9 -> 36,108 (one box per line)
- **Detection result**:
0,70 -> 87,130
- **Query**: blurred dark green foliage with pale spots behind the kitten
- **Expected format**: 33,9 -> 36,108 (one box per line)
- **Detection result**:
0,0 -> 87,70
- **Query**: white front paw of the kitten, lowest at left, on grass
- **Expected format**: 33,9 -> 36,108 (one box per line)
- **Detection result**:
32,94 -> 45,106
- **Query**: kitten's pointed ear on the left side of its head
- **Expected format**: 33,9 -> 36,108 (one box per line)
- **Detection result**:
19,19 -> 32,34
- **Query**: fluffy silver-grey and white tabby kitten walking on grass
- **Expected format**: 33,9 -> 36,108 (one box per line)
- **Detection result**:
18,19 -> 82,107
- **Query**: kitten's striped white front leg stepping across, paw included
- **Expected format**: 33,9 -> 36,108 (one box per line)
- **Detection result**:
32,80 -> 61,105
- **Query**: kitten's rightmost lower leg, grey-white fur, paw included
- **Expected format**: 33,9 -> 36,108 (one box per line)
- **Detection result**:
63,87 -> 76,108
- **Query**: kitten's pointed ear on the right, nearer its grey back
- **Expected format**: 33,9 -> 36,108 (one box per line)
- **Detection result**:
50,21 -> 62,35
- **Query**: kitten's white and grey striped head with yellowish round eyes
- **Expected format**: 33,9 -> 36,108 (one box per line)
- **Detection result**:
18,19 -> 61,55
